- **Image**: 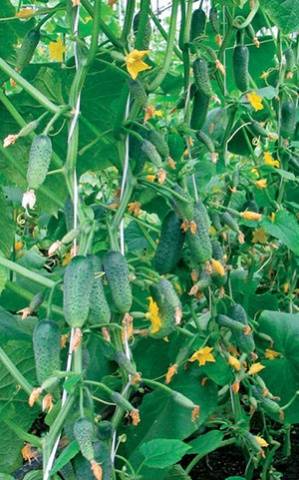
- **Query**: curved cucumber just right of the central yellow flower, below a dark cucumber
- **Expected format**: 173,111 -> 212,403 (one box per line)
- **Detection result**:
151,278 -> 182,338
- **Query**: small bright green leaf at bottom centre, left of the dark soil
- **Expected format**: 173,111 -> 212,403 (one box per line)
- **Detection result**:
139,438 -> 190,468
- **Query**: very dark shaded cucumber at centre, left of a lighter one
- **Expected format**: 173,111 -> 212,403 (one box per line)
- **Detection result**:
154,212 -> 185,274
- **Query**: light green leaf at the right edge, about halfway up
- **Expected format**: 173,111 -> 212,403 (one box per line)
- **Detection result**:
261,210 -> 299,255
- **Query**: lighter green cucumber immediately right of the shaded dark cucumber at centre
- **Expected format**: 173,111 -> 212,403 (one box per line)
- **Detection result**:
186,205 -> 212,263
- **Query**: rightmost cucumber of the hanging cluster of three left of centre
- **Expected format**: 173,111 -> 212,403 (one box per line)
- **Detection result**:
103,251 -> 133,313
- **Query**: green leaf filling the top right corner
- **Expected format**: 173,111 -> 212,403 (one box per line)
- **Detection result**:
260,0 -> 299,33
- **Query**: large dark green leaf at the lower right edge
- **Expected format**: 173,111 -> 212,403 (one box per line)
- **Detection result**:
259,310 -> 299,423
